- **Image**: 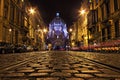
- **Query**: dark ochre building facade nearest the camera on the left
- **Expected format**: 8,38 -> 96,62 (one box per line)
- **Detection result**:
0,0 -> 29,44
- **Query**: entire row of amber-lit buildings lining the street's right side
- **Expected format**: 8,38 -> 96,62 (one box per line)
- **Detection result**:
72,0 -> 120,51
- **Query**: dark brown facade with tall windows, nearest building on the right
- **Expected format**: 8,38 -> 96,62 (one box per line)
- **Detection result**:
88,0 -> 120,44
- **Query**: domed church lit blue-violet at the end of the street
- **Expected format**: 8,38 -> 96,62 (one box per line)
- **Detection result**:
48,13 -> 69,49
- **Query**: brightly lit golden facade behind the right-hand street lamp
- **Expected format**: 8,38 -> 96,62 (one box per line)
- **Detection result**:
71,0 -> 89,46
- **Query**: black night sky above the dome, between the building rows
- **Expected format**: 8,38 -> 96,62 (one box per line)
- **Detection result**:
29,0 -> 81,27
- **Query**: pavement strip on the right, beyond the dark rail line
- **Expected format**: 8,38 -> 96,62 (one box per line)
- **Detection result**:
73,52 -> 120,69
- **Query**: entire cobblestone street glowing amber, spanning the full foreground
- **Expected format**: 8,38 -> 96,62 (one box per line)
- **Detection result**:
0,51 -> 120,80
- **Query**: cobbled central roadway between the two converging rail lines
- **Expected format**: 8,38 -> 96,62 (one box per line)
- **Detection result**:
0,52 -> 120,80
